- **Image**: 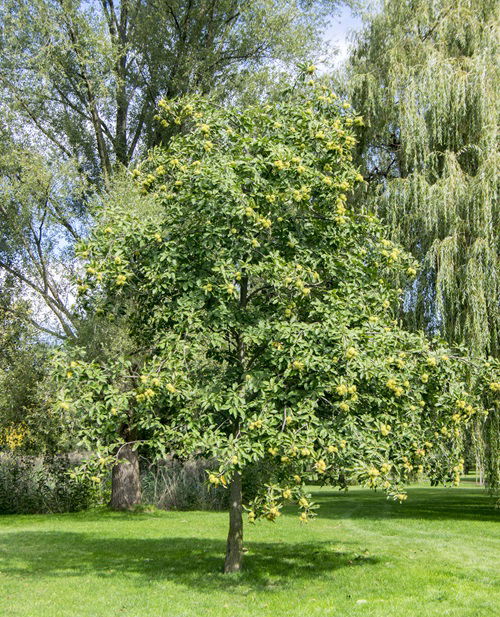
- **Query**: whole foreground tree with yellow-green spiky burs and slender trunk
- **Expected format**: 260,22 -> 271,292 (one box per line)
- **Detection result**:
61,79 -> 500,572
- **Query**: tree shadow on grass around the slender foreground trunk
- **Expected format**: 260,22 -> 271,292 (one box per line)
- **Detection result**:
0,531 -> 378,591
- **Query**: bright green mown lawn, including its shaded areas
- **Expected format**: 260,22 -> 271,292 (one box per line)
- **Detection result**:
0,482 -> 500,617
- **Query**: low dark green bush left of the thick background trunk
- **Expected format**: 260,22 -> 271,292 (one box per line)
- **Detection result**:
0,453 -> 103,514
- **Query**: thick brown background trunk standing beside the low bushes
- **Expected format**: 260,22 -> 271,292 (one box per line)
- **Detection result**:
109,444 -> 141,510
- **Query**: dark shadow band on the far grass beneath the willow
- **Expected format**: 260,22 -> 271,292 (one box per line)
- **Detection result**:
313,487 -> 500,522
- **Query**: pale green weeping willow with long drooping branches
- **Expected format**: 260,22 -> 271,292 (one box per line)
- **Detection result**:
349,0 -> 500,485
